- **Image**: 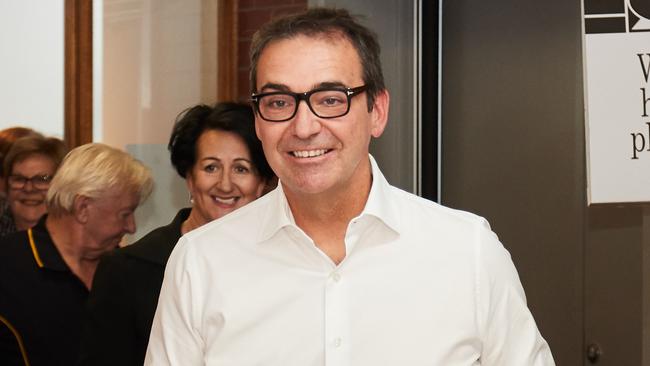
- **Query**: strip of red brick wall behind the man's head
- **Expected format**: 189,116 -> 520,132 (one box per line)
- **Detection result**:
237,0 -> 307,100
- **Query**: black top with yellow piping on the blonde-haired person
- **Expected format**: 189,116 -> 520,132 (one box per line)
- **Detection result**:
0,216 -> 88,366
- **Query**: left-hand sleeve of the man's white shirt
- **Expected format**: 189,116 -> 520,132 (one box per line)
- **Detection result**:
144,237 -> 204,366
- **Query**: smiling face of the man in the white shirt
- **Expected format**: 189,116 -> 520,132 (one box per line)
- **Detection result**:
255,35 -> 388,198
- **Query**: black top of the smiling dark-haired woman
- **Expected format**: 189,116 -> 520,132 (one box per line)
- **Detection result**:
79,208 -> 190,366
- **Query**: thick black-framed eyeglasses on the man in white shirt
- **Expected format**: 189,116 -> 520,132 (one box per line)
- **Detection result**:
251,85 -> 367,122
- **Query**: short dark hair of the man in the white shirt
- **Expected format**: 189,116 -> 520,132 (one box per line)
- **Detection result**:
250,8 -> 386,111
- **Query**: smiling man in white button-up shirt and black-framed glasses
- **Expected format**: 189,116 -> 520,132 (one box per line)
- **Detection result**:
145,9 -> 554,366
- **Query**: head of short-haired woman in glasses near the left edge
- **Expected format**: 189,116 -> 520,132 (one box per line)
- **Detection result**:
0,134 -> 67,236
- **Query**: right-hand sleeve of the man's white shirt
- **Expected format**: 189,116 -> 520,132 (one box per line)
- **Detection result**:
476,221 -> 555,366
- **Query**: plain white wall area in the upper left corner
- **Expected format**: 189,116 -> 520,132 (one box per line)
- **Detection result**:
0,0 -> 64,138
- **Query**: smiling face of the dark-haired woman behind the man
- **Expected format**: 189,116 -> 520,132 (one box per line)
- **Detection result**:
186,130 -> 265,225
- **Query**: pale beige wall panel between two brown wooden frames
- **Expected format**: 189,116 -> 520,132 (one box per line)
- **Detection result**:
96,0 -> 217,243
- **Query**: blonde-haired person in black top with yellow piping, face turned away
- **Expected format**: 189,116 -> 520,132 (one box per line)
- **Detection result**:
0,143 -> 153,366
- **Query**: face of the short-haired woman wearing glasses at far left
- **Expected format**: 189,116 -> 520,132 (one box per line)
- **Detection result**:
7,154 -> 55,230
